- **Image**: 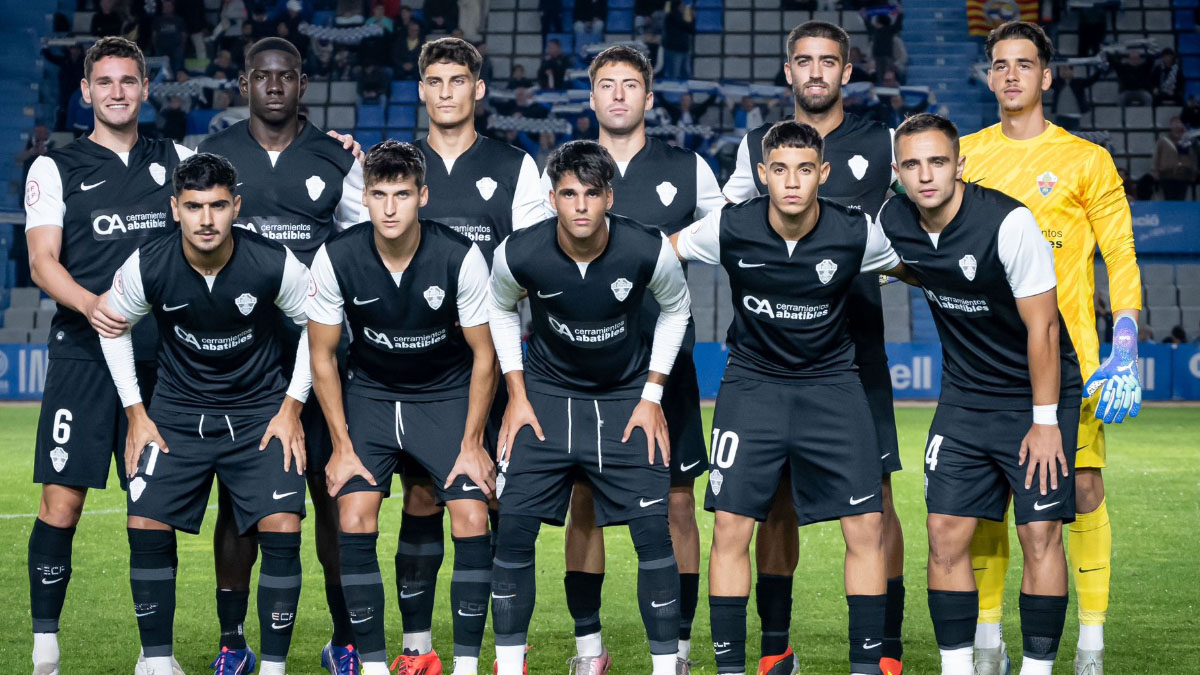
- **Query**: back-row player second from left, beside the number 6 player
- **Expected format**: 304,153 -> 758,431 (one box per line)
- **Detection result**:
199,37 -> 366,675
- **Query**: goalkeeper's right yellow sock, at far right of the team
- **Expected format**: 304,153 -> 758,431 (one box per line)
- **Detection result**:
1070,501 -> 1112,626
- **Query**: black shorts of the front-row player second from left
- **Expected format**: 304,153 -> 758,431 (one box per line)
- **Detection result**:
338,394 -> 487,503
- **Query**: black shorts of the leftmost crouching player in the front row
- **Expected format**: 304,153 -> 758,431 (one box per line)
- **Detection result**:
127,411 -> 305,534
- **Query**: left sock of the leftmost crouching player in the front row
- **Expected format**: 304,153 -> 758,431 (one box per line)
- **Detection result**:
127,527 -> 175,658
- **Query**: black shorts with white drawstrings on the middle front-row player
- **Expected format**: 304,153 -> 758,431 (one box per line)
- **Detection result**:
496,392 -> 671,527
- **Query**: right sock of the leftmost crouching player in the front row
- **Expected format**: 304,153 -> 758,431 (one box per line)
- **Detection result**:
258,532 -> 302,663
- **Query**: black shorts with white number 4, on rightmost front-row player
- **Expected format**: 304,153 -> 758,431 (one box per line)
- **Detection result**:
925,401 -> 1079,525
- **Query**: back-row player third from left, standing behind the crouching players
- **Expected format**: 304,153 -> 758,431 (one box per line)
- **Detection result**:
396,37 -> 545,675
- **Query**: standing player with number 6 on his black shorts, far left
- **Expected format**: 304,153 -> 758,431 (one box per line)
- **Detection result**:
25,37 -> 191,675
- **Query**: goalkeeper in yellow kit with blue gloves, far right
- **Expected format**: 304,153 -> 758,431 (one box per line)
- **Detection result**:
962,22 -> 1141,675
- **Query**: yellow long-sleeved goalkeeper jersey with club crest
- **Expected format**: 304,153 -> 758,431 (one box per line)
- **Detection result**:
961,124 -> 1141,372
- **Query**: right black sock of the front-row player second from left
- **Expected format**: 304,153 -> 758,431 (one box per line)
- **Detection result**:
450,534 -> 492,658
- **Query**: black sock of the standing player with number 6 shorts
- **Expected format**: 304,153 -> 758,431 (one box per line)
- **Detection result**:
29,519 -> 76,633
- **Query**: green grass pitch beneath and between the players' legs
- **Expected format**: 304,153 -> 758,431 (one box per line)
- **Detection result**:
0,407 -> 1200,675
